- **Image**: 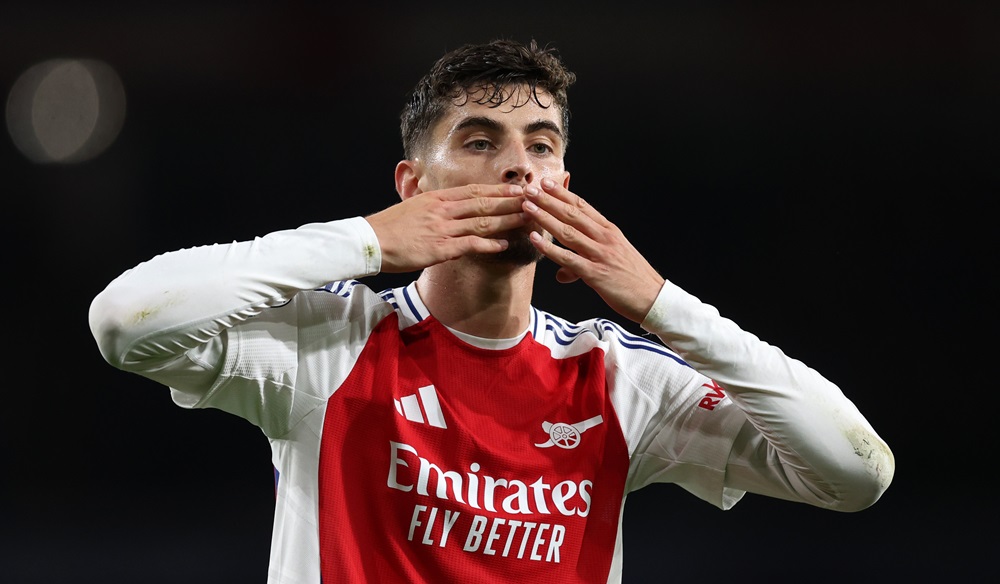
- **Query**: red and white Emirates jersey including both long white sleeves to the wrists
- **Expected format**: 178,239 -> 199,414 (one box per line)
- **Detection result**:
90,217 -> 893,584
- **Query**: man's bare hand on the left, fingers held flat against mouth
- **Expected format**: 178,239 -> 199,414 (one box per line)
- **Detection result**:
365,184 -> 527,273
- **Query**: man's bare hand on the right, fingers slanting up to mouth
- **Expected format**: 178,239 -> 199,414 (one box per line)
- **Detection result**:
524,179 -> 663,322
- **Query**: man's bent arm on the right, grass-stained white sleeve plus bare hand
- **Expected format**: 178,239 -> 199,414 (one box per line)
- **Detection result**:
524,183 -> 895,511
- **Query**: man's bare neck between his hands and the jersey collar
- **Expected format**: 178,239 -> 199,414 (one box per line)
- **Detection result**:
417,258 -> 535,339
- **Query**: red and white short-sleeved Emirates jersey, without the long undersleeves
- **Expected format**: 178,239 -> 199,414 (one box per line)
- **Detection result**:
195,281 -> 744,583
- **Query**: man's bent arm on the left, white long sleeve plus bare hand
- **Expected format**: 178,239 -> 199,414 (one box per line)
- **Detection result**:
90,185 -> 524,371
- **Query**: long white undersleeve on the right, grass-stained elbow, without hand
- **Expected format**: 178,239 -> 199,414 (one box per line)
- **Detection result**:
642,281 -> 895,511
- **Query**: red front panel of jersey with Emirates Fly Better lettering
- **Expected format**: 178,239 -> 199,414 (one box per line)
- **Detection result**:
319,313 -> 629,584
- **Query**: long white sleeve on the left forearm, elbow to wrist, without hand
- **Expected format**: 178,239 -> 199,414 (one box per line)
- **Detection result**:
90,218 -> 381,372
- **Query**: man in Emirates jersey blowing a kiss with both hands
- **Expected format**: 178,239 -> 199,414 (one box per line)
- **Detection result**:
90,41 -> 894,584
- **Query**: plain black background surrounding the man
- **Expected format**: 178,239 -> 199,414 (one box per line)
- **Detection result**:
0,1 -> 1000,584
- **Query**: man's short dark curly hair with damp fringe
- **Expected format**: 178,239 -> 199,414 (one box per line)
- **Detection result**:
400,39 -> 576,160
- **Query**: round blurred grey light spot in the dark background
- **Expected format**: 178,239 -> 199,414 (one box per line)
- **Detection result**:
7,59 -> 125,163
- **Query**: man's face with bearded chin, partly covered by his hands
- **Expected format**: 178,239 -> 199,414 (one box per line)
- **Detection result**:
418,86 -> 569,264
